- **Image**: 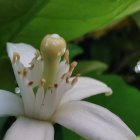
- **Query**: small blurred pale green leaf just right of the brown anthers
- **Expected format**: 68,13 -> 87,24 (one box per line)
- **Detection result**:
74,60 -> 108,75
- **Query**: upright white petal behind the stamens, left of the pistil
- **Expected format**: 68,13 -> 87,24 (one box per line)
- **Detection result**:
7,43 -> 36,67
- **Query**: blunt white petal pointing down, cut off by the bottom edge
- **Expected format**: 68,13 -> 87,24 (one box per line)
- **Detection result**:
4,118 -> 54,140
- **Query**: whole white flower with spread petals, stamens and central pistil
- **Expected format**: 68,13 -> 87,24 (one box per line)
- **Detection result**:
0,34 -> 136,140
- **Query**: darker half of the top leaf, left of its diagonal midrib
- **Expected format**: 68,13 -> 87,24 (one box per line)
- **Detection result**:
0,0 -> 49,50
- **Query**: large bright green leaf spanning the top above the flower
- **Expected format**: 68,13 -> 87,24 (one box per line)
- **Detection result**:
0,0 -> 140,47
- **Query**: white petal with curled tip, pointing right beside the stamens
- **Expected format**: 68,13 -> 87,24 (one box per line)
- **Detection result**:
61,77 -> 112,104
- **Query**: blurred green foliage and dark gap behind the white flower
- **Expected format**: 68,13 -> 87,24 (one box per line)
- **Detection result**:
0,0 -> 140,140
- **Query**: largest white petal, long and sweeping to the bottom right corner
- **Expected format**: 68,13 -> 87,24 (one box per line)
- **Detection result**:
54,101 -> 136,140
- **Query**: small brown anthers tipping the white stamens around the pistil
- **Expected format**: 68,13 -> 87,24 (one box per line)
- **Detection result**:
13,49 -> 80,89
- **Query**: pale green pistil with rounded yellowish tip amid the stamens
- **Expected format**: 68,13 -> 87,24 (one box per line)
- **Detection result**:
40,34 -> 68,89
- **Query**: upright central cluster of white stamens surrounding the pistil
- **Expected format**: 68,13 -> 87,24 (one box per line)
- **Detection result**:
9,35 -> 79,120
